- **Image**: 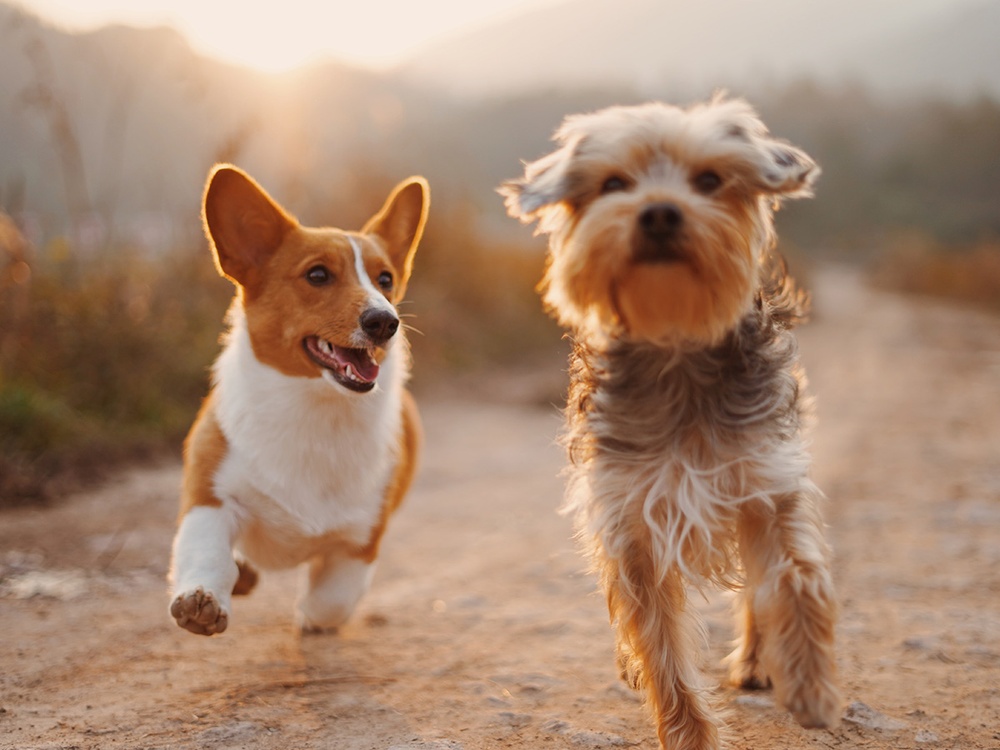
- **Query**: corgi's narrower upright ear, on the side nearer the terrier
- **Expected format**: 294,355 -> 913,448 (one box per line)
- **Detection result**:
361,177 -> 431,299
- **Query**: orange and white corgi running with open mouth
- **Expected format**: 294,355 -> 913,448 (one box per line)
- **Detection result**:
170,165 -> 430,635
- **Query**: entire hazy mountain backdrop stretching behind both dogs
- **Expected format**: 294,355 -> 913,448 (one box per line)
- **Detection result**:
0,0 -> 1000,250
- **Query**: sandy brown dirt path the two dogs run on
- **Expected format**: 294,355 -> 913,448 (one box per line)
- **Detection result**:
0,271 -> 1000,750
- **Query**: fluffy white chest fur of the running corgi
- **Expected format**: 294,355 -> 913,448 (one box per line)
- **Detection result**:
214,309 -> 405,564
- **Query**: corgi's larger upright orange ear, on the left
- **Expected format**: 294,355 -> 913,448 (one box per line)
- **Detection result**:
202,164 -> 298,287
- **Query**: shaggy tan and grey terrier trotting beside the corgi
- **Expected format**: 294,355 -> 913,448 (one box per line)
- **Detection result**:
501,97 -> 841,750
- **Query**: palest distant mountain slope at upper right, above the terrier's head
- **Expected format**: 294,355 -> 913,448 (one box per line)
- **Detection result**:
404,0 -> 1000,97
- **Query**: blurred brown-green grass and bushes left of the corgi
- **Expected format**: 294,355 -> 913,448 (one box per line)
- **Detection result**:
0,241 -> 231,504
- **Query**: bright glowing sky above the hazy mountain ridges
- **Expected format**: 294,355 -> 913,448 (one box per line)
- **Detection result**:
15,0 -> 554,72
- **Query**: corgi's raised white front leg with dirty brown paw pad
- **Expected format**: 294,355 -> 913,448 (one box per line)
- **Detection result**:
170,505 -> 239,635
